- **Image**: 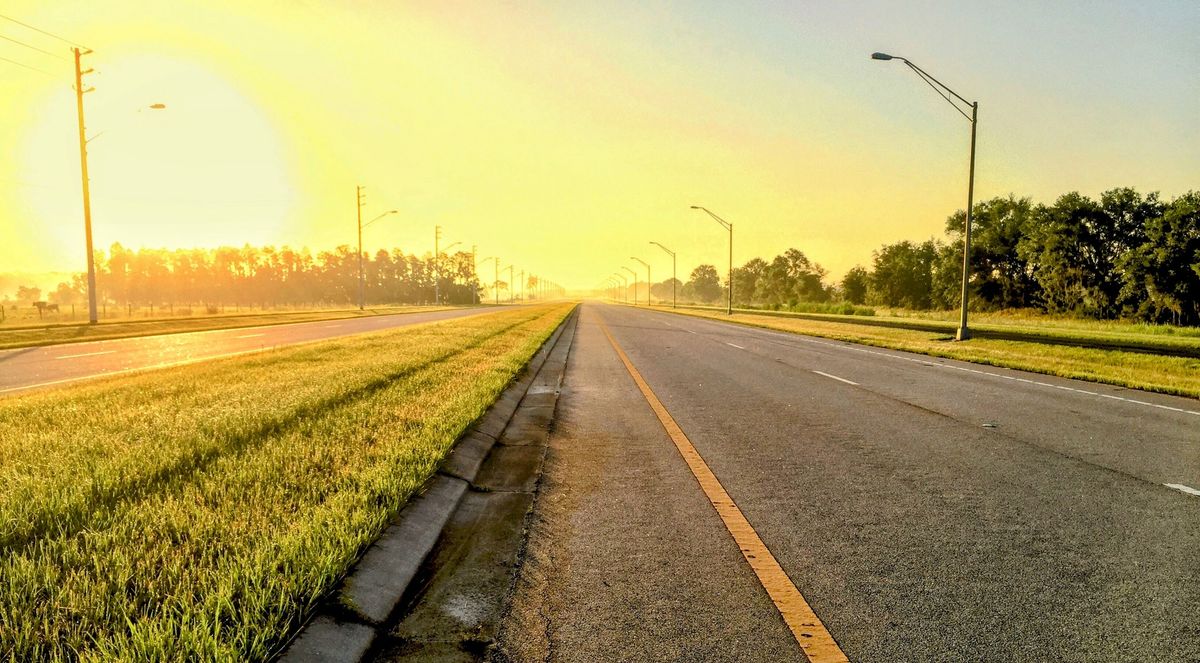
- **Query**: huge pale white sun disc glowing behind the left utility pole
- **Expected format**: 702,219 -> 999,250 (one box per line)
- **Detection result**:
17,54 -> 296,264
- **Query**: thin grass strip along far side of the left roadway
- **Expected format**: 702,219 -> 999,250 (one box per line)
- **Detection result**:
0,306 -> 457,350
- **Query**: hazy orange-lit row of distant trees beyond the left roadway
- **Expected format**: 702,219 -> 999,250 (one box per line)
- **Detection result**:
38,244 -> 487,305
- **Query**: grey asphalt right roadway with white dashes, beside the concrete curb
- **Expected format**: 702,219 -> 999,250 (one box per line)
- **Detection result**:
499,304 -> 1200,662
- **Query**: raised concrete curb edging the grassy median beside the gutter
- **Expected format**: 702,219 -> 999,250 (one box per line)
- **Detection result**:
278,307 -> 578,663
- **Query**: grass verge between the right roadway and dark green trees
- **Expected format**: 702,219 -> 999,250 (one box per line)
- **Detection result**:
668,309 -> 1200,398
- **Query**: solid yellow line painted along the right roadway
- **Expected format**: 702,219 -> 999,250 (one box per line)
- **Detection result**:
600,321 -> 850,663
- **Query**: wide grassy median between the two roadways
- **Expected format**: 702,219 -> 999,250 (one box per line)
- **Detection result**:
0,304 -> 571,661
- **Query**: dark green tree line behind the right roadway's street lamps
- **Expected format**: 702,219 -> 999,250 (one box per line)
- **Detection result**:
650,187 -> 1200,325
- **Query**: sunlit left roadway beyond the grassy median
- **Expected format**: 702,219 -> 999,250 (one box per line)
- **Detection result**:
0,306 -> 506,394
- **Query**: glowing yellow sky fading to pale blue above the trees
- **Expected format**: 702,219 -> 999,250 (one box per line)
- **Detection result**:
0,0 -> 1200,288
